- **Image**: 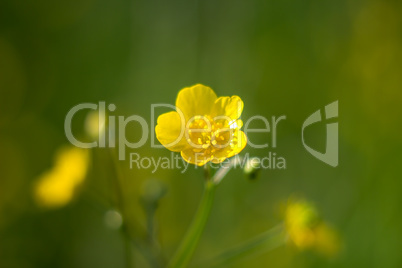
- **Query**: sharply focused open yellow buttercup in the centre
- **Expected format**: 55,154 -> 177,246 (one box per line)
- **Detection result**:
155,84 -> 247,166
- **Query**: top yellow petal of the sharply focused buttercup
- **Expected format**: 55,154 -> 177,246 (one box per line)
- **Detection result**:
176,84 -> 217,119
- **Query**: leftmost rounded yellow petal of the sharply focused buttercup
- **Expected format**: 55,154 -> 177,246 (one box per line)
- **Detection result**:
155,112 -> 187,152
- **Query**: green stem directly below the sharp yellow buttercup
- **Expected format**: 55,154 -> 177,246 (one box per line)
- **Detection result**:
168,171 -> 215,268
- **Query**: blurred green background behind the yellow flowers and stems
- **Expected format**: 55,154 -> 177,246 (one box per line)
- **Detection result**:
0,0 -> 402,268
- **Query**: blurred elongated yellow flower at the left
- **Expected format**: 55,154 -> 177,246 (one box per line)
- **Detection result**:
34,147 -> 89,208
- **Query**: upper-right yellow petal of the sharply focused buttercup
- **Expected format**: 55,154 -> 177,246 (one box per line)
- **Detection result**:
212,96 -> 244,120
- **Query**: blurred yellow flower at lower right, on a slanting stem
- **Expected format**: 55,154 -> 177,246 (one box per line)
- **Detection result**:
285,200 -> 340,256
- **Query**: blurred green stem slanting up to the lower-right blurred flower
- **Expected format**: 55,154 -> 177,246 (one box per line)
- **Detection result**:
196,225 -> 287,268
